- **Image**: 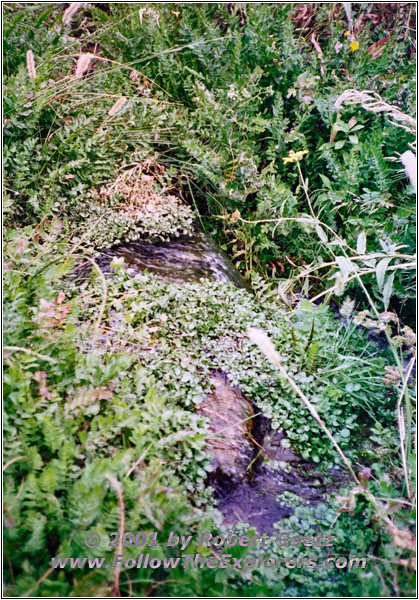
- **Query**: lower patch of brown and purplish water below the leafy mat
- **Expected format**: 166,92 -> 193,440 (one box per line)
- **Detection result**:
199,373 -> 349,535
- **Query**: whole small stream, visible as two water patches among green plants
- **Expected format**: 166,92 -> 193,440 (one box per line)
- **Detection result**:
79,229 -> 344,534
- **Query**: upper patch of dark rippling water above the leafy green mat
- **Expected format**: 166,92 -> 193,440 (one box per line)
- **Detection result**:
91,230 -> 249,289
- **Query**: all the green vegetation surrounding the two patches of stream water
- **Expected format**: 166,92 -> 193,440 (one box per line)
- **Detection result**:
3,3 -> 416,597
